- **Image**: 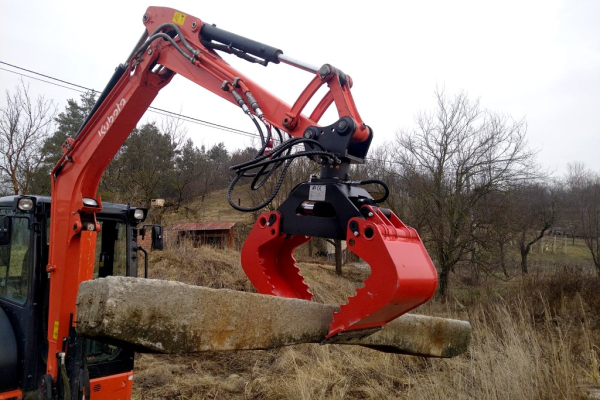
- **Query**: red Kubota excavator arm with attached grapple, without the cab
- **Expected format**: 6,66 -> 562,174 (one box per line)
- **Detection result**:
47,7 -> 437,380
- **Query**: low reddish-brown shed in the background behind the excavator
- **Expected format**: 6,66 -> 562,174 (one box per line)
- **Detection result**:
165,222 -> 235,248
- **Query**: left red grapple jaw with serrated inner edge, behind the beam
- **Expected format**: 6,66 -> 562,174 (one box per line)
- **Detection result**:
242,211 -> 312,300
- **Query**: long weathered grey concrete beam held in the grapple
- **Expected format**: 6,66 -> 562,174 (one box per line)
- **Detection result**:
76,277 -> 471,357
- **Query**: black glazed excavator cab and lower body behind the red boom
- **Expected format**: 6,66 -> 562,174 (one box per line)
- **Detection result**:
0,196 -> 152,399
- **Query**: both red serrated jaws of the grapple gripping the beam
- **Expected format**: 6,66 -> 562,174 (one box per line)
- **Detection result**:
242,206 -> 437,343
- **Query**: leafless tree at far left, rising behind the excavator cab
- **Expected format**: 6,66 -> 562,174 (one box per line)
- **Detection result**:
0,82 -> 56,194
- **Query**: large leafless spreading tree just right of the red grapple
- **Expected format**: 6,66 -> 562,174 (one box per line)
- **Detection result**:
396,89 -> 536,296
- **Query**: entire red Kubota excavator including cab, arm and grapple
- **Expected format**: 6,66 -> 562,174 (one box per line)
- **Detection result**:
0,7 -> 437,399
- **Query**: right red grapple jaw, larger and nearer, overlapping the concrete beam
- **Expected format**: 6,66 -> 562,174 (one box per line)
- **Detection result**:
327,208 -> 437,340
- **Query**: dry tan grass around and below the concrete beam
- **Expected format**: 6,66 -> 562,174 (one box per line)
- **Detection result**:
134,247 -> 600,400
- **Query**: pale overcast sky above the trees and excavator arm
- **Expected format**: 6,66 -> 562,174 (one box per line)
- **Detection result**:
0,0 -> 600,175
